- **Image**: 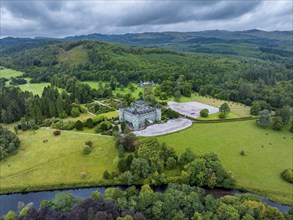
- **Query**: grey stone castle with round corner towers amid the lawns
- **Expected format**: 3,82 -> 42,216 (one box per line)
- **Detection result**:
119,100 -> 161,131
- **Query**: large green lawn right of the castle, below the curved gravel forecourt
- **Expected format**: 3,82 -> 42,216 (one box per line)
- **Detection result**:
158,120 -> 293,205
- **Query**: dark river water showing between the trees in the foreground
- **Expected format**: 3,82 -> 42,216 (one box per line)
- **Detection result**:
0,185 -> 291,217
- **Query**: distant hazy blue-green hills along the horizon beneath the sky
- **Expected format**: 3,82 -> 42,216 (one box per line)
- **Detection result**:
1,29 -> 293,67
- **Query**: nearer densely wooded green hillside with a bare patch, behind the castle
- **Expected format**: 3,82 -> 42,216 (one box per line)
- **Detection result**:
0,41 -> 293,108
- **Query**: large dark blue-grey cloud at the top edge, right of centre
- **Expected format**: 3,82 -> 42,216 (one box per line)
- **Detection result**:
119,0 -> 261,26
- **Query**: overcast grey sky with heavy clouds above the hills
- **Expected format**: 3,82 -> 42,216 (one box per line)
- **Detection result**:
0,0 -> 293,37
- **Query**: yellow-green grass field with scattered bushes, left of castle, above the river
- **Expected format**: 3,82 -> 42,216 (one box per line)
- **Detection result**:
0,129 -> 116,193
